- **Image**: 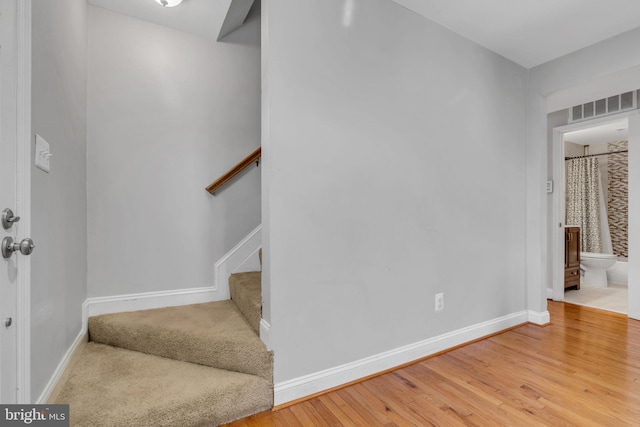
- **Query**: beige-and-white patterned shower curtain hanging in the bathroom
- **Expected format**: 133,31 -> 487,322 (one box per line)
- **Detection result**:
565,157 -> 602,252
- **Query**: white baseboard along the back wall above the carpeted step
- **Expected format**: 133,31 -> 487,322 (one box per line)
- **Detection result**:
82,287 -> 221,328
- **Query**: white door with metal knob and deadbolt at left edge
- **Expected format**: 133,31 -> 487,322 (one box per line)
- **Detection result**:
0,0 -> 20,403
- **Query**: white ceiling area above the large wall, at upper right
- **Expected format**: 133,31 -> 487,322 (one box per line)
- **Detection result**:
393,0 -> 640,68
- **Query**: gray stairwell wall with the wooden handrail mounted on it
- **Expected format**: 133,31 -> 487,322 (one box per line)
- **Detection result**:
88,6 -> 261,297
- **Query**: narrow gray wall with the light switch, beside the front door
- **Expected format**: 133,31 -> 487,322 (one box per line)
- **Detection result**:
31,0 -> 87,400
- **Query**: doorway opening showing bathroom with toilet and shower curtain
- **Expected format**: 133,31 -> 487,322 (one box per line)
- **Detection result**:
552,112 -> 635,314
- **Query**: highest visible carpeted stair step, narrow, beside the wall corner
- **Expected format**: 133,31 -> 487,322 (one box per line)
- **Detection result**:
229,271 -> 262,335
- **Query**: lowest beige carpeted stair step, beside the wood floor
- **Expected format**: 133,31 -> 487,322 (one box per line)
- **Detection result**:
55,342 -> 273,427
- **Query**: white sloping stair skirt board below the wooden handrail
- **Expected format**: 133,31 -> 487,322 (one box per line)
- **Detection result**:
213,224 -> 262,299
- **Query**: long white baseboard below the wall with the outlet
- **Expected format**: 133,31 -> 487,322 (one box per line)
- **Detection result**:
274,311 -> 530,405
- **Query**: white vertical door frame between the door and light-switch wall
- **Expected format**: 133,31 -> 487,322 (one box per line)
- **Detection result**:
13,0 -> 32,403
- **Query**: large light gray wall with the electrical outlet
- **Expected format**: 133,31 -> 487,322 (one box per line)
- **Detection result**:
263,0 -> 527,382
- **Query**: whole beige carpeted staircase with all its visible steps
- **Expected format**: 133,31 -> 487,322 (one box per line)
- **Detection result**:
53,272 -> 273,427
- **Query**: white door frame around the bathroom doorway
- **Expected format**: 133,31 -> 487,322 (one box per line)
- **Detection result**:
550,110 -> 640,313
